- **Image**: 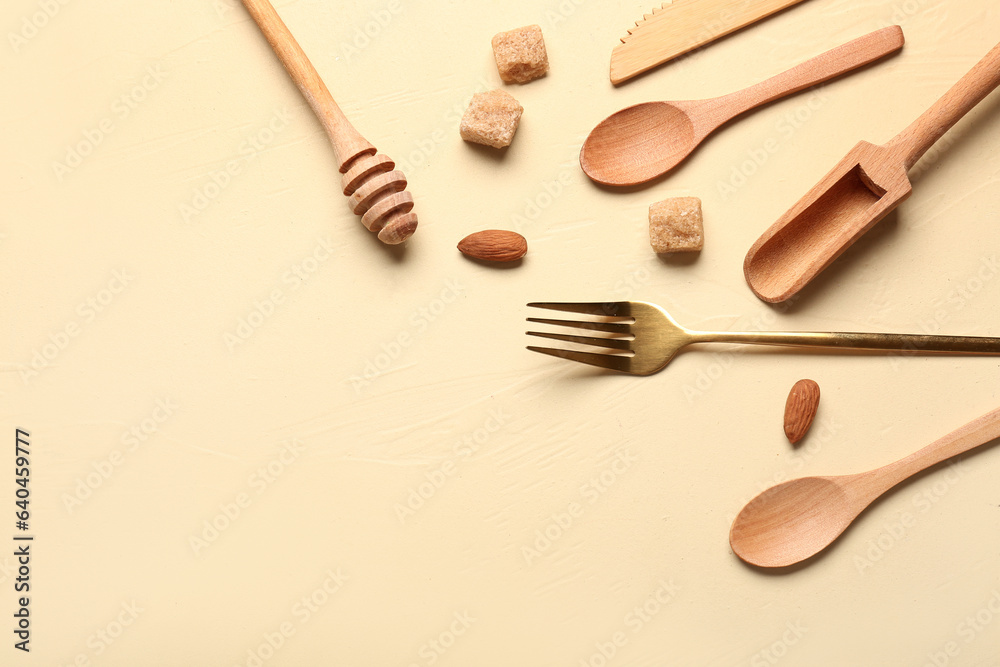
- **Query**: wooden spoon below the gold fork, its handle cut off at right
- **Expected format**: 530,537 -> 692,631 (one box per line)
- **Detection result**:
729,402 -> 1000,567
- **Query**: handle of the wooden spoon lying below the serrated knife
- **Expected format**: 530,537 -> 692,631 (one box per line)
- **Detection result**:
713,25 -> 904,118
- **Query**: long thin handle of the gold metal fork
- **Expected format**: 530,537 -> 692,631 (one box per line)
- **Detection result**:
691,331 -> 1000,354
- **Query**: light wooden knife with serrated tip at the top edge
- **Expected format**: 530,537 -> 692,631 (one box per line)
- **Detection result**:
611,0 -> 802,85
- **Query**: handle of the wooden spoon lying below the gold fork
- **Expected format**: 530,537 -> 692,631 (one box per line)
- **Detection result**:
858,408 -> 1000,499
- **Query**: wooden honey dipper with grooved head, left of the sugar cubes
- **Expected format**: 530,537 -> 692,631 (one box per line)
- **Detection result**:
243,0 -> 417,245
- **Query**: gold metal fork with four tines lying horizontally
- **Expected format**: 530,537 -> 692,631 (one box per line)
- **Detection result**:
527,301 -> 1000,375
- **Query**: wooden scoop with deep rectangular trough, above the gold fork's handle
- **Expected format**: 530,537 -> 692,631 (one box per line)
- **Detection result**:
743,39 -> 1000,303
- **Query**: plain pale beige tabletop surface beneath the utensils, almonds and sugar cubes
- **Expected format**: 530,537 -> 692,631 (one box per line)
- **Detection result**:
0,0 -> 1000,667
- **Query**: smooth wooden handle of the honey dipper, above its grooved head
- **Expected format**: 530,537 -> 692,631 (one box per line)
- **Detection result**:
243,0 -> 375,173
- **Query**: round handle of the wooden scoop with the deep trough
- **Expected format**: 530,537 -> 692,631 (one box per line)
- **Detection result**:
888,44 -> 1000,170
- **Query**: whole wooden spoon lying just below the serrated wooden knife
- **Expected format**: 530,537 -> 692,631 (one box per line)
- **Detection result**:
580,26 -> 903,185
